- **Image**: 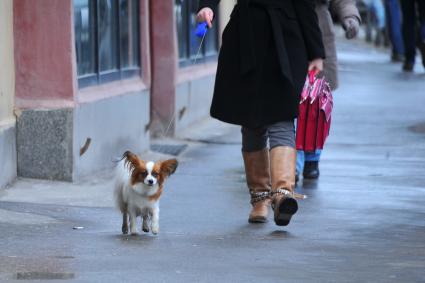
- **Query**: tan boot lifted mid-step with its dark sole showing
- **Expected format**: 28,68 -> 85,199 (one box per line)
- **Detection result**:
270,146 -> 305,226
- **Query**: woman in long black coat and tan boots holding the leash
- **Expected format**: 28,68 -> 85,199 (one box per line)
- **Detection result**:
197,0 -> 325,225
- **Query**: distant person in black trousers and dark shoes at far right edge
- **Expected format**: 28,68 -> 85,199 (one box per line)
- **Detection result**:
400,0 -> 425,72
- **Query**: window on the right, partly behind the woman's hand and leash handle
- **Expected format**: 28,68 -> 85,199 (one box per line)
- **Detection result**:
174,0 -> 218,66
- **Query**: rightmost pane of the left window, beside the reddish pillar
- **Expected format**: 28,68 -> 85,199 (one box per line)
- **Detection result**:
119,0 -> 140,68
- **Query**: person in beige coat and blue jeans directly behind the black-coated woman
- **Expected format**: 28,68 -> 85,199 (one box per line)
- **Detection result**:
296,0 -> 360,182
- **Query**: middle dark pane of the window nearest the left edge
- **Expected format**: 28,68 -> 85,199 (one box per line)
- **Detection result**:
98,0 -> 118,72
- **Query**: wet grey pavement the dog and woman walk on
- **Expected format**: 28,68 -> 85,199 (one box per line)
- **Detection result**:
0,40 -> 425,282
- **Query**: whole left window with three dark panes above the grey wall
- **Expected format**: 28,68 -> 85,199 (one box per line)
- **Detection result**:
74,0 -> 140,87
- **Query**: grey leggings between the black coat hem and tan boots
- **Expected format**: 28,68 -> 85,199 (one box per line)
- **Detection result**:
242,121 -> 295,152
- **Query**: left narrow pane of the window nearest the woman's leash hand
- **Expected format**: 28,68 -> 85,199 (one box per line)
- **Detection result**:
174,0 -> 189,59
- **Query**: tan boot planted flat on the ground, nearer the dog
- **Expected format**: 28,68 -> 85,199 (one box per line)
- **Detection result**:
242,149 -> 270,223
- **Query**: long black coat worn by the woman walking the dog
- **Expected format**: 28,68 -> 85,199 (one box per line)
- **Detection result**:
199,0 -> 325,128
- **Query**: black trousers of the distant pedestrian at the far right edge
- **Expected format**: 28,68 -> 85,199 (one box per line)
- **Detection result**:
400,0 -> 425,62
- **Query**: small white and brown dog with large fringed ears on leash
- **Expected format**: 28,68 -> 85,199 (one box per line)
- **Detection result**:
114,151 -> 178,235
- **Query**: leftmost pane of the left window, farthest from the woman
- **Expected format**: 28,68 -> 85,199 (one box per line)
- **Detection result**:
74,0 -> 96,76
